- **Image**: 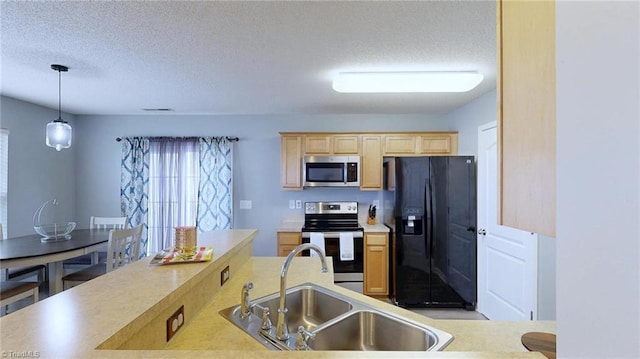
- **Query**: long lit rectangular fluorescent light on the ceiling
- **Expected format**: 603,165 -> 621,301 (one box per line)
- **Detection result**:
333,71 -> 484,93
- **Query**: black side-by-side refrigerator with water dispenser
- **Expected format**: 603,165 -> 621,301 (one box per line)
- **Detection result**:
391,156 -> 477,310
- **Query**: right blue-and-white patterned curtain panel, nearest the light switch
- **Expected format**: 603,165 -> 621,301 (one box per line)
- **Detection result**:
196,137 -> 233,232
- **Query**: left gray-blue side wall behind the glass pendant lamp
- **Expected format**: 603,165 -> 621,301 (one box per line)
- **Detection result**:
0,96 -> 77,237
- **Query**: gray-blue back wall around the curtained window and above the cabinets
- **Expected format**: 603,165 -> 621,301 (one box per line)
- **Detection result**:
74,115 -> 449,256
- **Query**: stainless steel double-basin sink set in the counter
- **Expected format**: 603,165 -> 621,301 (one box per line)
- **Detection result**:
220,283 -> 453,351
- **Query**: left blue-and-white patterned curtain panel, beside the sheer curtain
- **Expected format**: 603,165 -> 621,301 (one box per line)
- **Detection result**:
120,137 -> 149,257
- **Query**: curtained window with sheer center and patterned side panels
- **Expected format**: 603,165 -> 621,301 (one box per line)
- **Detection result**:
120,137 -> 235,256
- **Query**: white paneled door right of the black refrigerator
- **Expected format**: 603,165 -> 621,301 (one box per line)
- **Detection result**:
477,122 -> 538,320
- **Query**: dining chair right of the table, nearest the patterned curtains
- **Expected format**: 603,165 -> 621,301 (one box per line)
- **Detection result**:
62,225 -> 142,290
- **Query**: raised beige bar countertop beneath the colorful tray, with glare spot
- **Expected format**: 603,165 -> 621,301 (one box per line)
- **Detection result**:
0,229 -> 257,358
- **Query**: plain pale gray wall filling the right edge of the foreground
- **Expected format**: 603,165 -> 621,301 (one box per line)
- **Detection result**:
556,1 -> 640,358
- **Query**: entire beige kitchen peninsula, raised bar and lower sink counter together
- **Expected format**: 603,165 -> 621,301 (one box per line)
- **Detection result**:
0,230 -> 555,359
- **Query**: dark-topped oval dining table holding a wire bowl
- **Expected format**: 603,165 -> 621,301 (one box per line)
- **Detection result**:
0,229 -> 110,295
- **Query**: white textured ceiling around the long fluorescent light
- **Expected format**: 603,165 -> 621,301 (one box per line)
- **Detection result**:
0,1 -> 496,114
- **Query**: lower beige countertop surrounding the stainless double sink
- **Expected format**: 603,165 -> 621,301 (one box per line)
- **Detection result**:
166,257 -> 555,358
